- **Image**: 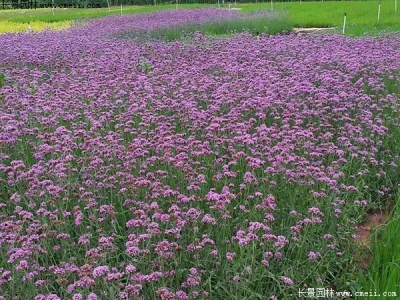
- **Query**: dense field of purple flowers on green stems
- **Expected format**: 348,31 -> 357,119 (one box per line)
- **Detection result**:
0,9 -> 400,300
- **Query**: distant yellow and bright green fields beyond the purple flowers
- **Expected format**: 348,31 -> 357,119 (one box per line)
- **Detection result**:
0,0 -> 400,36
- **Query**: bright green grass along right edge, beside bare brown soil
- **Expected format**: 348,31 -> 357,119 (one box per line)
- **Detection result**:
356,77 -> 400,300
